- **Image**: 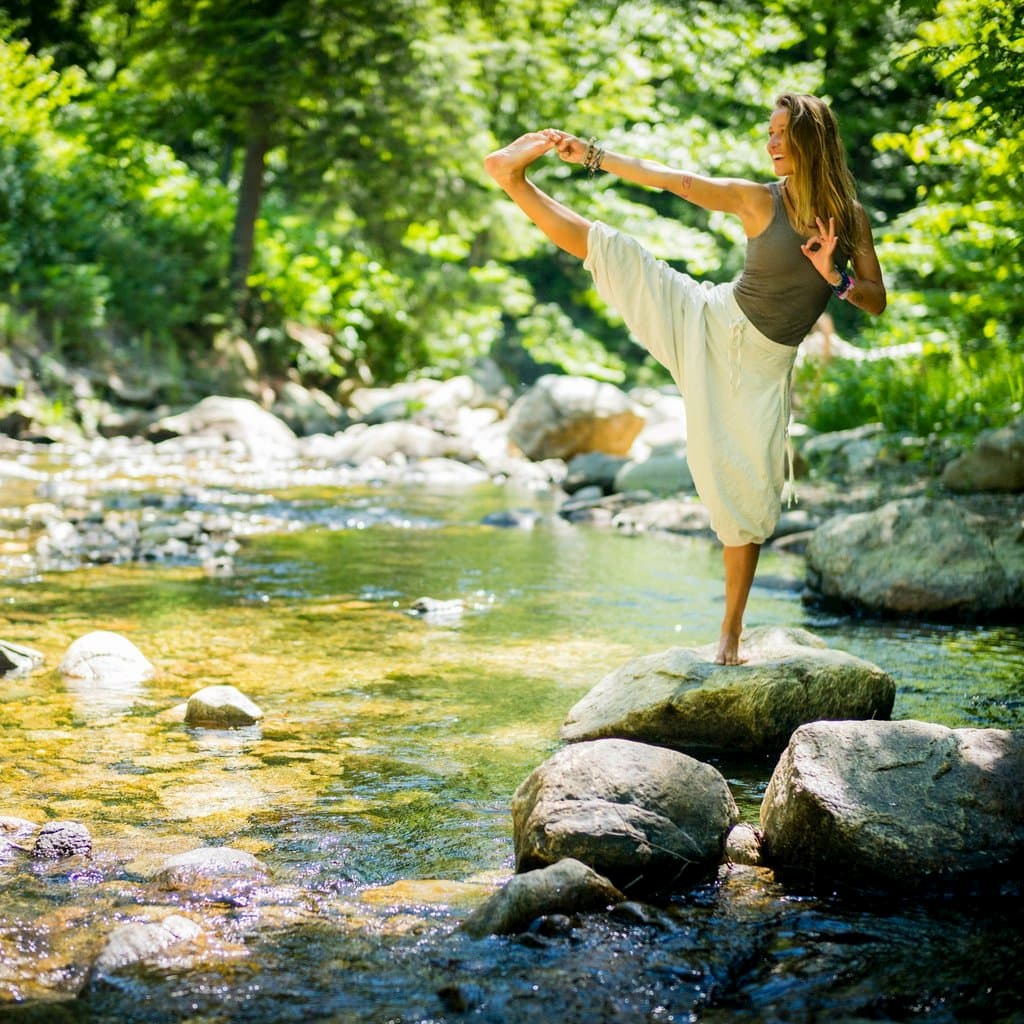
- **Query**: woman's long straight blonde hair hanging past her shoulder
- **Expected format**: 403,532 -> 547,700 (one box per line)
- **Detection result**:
775,92 -> 860,257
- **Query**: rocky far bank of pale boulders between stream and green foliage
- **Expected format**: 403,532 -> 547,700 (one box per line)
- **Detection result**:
0,374 -> 1024,620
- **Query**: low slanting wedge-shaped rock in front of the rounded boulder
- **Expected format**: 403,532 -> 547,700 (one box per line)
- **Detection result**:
462,857 -> 626,938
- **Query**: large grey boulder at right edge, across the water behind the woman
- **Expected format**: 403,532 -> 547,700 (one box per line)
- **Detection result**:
807,498 -> 1024,617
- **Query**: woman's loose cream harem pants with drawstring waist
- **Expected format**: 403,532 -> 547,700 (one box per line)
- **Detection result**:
584,221 -> 797,546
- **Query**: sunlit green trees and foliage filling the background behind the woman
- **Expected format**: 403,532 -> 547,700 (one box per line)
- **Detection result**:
0,0 -> 1024,433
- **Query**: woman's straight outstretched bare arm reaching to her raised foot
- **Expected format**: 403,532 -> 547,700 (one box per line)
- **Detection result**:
542,128 -> 771,234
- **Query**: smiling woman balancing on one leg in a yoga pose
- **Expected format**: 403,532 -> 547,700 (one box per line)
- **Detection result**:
484,93 -> 886,665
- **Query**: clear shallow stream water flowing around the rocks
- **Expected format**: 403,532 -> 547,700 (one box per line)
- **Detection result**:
0,466 -> 1024,1024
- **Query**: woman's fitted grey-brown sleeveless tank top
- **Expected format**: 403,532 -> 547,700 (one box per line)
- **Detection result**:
733,181 -> 846,345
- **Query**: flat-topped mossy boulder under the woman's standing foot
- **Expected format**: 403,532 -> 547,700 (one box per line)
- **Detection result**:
561,627 -> 896,755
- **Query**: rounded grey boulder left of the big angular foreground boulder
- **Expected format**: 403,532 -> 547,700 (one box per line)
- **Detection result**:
512,739 -> 737,891
